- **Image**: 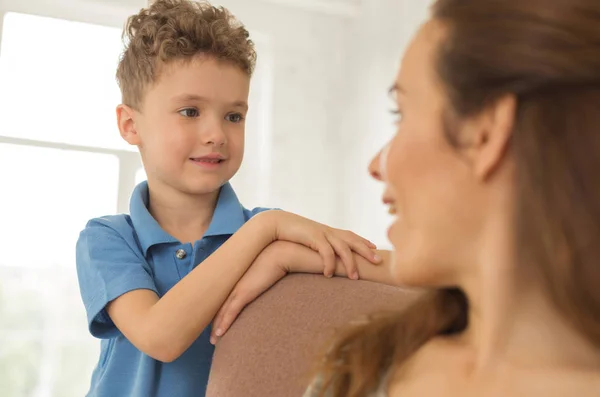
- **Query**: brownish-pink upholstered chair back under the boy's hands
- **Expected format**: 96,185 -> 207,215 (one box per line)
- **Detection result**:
206,274 -> 411,397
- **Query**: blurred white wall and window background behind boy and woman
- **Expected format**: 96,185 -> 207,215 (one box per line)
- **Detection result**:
0,0 -> 429,397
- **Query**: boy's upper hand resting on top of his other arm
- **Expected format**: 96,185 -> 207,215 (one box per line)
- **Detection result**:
264,211 -> 381,280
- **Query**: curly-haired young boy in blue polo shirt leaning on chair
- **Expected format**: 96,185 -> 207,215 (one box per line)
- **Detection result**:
77,0 -> 390,397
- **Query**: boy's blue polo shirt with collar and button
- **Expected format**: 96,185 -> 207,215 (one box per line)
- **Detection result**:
77,182 -> 265,397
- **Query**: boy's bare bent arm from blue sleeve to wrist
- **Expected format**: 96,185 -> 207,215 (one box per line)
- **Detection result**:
107,215 -> 274,362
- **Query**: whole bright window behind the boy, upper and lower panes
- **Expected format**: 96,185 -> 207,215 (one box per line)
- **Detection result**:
0,13 -> 139,397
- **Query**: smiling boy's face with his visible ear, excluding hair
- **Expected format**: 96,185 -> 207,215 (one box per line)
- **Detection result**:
118,56 -> 250,194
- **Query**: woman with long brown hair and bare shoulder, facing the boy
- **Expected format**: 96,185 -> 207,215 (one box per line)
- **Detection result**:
307,0 -> 600,397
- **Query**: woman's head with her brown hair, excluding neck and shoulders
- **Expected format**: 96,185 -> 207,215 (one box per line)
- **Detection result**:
371,0 -> 600,342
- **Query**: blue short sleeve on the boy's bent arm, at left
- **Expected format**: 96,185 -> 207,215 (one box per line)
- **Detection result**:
76,219 -> 158,338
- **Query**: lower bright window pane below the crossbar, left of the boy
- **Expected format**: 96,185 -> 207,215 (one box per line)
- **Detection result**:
0,144 -> 119,397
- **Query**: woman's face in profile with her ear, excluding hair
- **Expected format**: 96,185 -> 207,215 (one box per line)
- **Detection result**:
371,19 -> 515,287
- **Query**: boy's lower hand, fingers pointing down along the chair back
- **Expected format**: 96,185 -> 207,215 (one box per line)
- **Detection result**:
210,242 -> 288,345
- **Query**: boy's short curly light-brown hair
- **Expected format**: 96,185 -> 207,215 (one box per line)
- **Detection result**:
117,0 -> 256,109
